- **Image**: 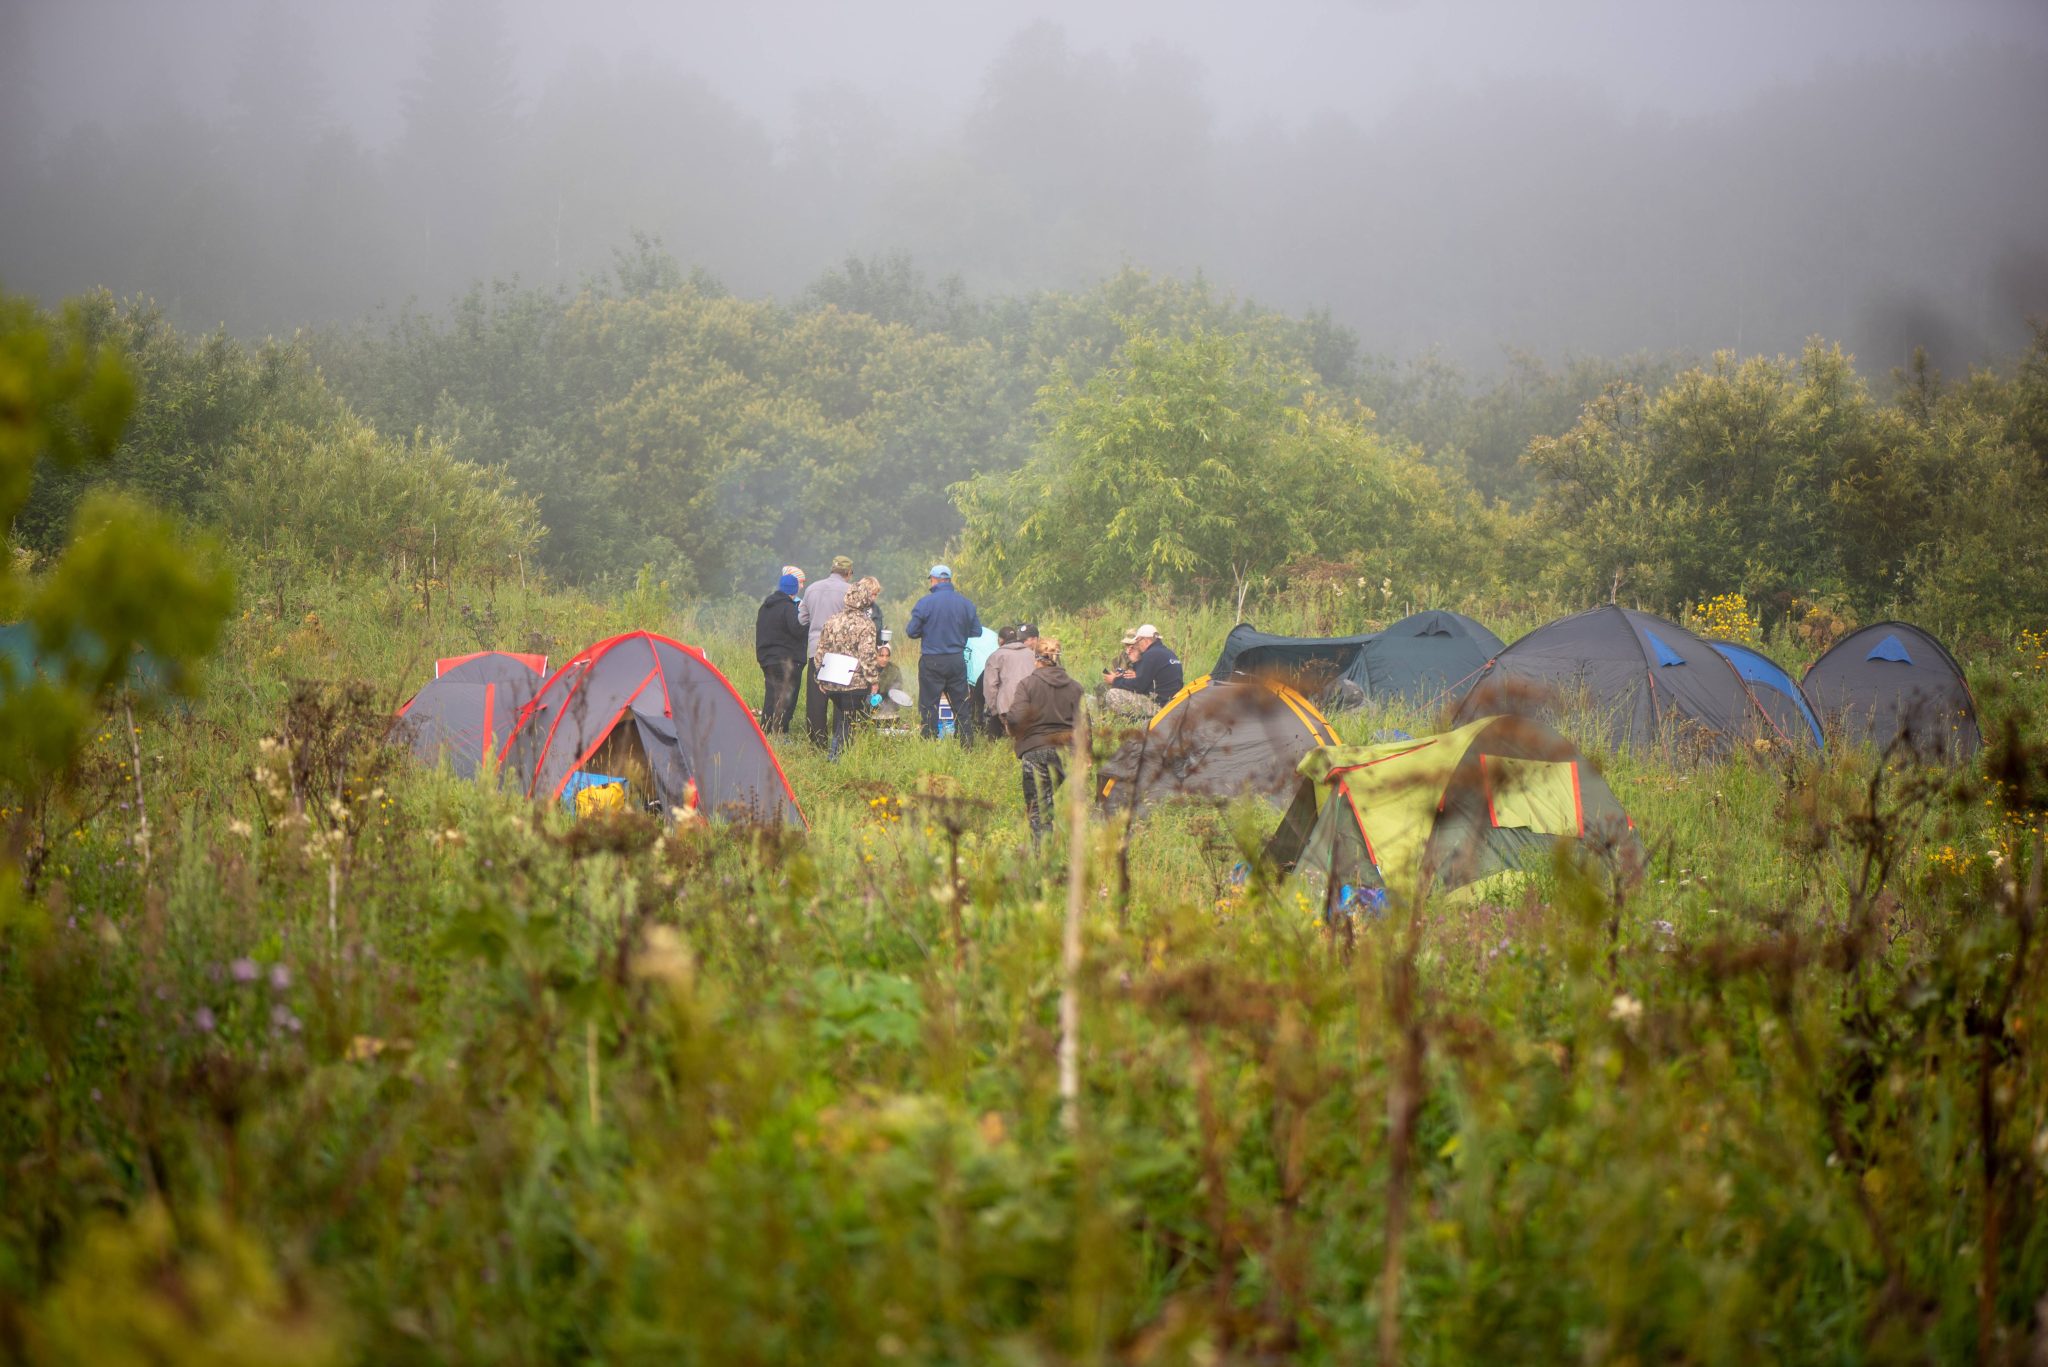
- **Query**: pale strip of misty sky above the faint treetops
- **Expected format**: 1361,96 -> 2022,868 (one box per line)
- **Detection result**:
19,0 -> 2048,146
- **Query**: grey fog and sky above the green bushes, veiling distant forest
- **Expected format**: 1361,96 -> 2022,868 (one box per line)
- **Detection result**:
0,0 -> 2048,369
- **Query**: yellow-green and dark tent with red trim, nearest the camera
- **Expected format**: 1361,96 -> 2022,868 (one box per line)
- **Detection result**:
1266,717 -> 1642,914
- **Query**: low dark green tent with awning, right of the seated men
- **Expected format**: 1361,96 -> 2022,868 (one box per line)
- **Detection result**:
1210,611 -> 1501,707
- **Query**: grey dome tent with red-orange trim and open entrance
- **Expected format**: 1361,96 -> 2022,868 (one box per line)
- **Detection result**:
500,631 -> 803,824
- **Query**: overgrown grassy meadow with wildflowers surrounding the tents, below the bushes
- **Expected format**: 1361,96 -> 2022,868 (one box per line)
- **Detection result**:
0,565 -> 2048,1363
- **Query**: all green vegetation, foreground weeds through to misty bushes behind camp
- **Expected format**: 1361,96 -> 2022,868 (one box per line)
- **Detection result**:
0,280 -> 2048,1363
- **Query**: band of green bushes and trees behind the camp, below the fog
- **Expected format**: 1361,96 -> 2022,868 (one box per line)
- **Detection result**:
12,259 -> 2048,631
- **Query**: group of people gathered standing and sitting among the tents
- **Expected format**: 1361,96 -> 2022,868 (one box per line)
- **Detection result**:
754,555 -> 1182,848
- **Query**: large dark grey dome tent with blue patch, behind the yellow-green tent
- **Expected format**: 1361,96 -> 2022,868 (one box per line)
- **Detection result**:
1454,603 -> 1796,750
